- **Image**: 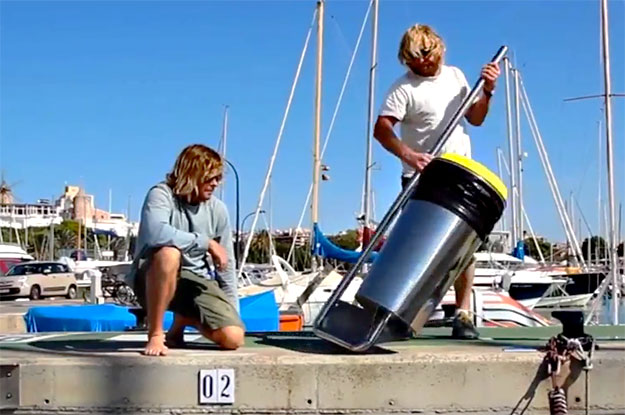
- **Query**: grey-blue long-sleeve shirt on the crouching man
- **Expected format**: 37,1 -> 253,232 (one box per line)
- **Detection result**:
134,183 -> 239,309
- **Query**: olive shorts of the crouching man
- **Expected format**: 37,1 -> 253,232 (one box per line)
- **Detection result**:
135,261 -> 245,330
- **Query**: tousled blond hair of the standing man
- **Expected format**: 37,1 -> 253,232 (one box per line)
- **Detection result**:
397,24 -> 445,65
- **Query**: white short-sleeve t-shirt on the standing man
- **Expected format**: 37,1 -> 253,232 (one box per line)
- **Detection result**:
380,65 -> 471,176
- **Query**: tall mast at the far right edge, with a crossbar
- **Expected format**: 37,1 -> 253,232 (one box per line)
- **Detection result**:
601,0 -> 620,325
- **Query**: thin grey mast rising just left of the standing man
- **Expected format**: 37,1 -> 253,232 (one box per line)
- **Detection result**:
363,0 -> 378,226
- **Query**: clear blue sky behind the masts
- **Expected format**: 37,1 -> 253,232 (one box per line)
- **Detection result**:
0,0 -> 625,240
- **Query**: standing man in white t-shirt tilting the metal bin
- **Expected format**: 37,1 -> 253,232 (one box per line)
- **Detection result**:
374,24 -> 499,339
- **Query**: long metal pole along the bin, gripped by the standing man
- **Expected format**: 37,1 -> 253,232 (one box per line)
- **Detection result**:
315,46 -> 508,326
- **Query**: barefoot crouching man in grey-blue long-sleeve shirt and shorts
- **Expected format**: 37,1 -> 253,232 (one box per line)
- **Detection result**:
131,144 -> 245,356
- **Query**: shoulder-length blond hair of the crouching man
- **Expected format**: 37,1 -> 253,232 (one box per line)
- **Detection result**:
165,144 -> 223,203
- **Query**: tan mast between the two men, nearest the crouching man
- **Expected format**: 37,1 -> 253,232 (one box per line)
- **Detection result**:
311,0 -> 324,228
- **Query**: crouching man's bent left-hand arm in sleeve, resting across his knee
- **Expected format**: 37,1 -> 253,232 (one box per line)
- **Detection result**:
141,186 -> 209,252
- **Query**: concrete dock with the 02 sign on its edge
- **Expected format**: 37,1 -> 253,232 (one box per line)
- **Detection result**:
0,326 -> 625,414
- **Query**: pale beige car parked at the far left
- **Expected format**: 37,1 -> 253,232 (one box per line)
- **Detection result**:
0,261 -> 77,300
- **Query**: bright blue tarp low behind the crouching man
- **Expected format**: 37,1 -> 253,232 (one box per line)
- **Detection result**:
24,291 -> 280,332
